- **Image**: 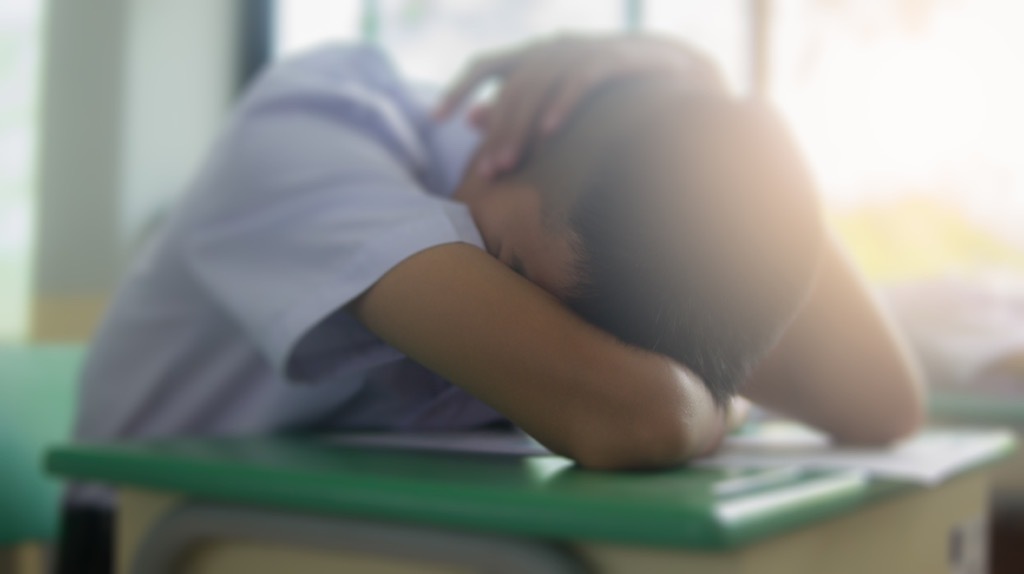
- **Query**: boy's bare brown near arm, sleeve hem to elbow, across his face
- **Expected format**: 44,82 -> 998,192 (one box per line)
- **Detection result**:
350,239 -> 724,469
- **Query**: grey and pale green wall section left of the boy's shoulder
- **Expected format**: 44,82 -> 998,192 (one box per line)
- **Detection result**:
31,0 -> 244,341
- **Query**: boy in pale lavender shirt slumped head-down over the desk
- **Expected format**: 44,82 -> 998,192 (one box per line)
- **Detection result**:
54,38 -> 921,572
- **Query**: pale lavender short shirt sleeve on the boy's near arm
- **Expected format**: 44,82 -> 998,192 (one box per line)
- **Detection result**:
180,65 -> 482,380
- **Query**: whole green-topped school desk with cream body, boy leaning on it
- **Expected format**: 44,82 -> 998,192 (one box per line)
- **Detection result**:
47,438 -> 1006,574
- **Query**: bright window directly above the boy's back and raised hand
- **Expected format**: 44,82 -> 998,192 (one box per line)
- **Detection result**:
273,0 -> 746,86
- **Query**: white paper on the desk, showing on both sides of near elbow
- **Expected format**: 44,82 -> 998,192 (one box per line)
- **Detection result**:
330,424 -> 1015,485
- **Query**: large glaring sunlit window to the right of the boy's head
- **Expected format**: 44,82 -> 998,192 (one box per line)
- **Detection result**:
771,0 -> 1024,281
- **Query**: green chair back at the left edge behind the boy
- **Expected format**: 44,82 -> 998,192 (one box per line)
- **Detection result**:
0,346 -> 85,546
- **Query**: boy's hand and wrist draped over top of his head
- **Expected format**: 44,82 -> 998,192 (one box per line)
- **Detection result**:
435,36 -> 723,178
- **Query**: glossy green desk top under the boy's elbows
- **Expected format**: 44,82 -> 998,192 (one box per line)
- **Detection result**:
46,438 -> 937,549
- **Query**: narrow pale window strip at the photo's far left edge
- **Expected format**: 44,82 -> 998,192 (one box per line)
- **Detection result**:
0,0 -> 42,341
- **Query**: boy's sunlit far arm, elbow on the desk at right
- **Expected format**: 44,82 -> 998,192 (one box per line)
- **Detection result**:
743,239 -> 924,444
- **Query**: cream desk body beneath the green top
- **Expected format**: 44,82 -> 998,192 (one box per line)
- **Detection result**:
118,469 -> 988,574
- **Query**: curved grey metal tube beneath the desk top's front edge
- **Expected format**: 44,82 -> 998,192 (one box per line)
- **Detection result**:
122,487 -> 586,574
